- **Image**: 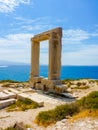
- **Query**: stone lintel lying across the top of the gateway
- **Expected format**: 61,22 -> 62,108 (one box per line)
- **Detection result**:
31,27 -> 62,41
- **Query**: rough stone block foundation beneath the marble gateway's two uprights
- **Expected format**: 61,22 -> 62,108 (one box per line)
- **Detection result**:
31,77 -> 66,93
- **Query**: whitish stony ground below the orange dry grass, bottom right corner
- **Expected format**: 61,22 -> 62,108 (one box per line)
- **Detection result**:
47,118 -> 98,130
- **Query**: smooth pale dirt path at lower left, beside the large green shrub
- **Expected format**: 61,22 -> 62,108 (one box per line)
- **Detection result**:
0,104 -> 54,128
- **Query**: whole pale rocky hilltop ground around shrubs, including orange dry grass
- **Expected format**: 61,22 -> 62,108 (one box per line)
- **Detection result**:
0,79 -> 98,130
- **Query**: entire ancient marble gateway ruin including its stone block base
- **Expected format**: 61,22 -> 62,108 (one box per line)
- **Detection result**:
30,27 -> 65,93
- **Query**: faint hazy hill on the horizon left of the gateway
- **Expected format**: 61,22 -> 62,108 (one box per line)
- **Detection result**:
0,60 -> 29,66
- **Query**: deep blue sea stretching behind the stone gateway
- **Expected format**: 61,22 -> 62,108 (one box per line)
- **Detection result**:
0,65 -> 98,81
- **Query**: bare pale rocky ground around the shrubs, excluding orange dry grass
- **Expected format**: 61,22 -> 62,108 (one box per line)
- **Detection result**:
0,79 -> 98,130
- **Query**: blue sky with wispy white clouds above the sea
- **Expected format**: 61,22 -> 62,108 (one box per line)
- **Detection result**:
0,0 -> 98,65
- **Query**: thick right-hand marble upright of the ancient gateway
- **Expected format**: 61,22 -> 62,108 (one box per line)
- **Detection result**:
48,33 -> 61,80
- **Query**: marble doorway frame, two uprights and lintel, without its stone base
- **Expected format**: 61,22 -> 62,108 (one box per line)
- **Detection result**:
30,27 -> 62,80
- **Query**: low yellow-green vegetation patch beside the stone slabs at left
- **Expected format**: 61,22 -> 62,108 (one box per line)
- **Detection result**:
7,98 -> 39,111
